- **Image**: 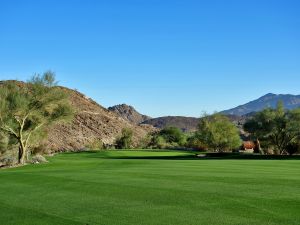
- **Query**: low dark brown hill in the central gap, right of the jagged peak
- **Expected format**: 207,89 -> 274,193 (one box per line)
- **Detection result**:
142,116 -> 199,132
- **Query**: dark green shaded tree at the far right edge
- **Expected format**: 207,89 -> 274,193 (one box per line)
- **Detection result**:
244,102 -> 300,154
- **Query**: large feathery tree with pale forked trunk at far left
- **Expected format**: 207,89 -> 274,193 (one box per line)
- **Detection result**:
0,71 -> 74,164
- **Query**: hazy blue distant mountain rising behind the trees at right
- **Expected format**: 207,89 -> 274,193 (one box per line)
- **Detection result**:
221,93 -> 300,116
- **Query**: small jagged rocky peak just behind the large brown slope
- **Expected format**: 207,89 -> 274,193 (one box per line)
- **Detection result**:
108,104 -> 151,124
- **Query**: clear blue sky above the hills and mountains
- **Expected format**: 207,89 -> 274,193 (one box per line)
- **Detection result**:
0,0 -> 300,116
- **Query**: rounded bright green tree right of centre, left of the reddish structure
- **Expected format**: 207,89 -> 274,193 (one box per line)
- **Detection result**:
195,114 -> 241,152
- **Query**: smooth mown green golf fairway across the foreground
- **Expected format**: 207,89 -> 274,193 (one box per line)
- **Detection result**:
0,151 -> 300,225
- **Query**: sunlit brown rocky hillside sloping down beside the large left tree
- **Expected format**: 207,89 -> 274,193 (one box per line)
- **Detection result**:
46,88 -> 155,151
